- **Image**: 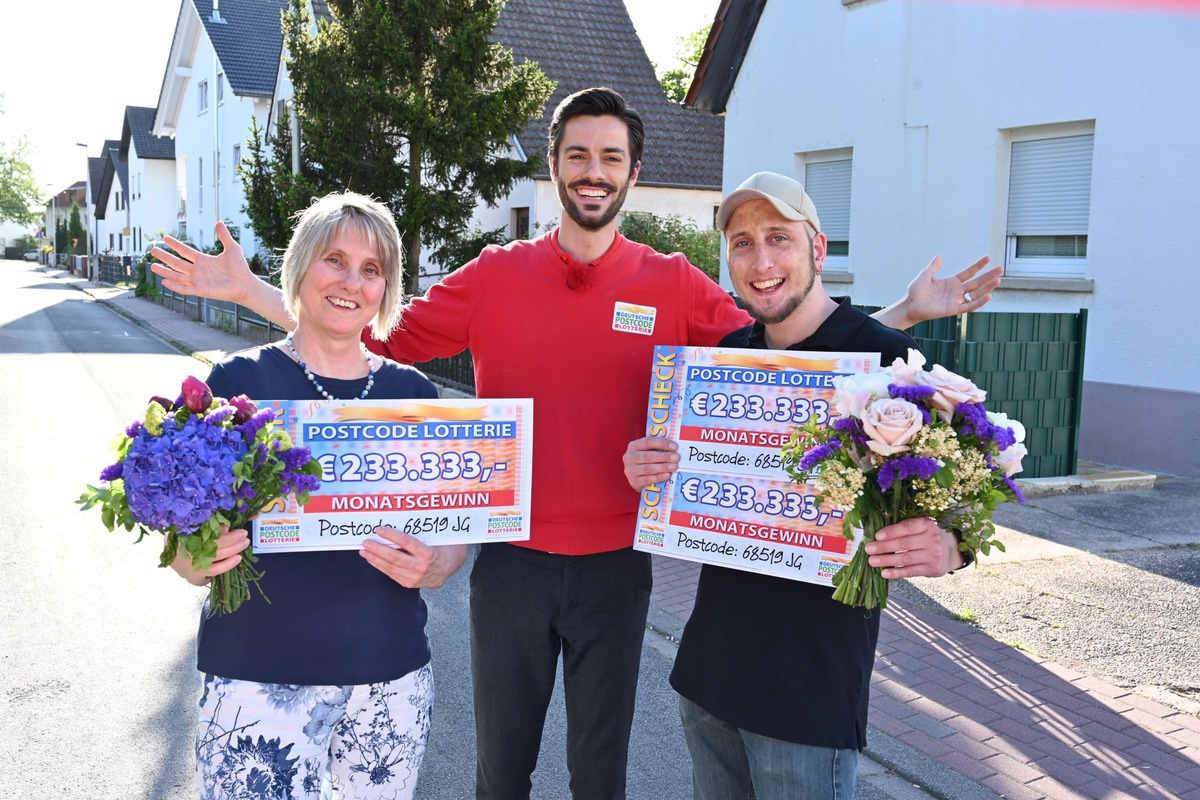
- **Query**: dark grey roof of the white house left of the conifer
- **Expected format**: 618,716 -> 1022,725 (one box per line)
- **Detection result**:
192,0 -> 288,97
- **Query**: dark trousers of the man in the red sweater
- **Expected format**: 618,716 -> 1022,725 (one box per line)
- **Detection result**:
470,543 -> 653,800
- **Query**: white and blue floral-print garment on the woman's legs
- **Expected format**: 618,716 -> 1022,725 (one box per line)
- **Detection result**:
196,664 -> 433,800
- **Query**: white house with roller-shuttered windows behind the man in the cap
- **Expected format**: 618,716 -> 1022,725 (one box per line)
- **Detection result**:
689,0 -> 1200,476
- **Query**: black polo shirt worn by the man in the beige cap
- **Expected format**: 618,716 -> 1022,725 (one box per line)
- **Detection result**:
671,297 -> 917,750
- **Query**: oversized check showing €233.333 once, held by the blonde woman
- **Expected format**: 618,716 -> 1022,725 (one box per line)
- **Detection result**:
252,399 -> 533,553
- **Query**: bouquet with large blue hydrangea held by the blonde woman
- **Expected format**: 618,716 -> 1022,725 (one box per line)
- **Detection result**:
77,377 -> 320,614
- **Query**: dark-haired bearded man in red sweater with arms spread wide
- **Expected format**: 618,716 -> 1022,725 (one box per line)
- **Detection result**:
152,89 -> 998,800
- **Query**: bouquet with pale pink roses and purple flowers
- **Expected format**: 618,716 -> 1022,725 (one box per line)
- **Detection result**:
784,350 -> 1027,608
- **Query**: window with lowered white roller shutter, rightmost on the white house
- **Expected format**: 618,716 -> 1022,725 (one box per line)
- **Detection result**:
1004,126 -> 1096,278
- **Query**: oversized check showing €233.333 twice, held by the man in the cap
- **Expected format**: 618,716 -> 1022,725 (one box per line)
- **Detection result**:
634,347 -> 880,585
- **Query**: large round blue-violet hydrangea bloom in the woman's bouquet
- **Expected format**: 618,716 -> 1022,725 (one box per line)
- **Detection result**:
124,417 -> 246,535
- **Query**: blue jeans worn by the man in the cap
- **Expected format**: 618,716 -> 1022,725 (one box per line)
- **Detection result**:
679,697 -> 858,800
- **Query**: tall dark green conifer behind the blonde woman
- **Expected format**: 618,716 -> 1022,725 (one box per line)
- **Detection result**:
255,0 -> 553,293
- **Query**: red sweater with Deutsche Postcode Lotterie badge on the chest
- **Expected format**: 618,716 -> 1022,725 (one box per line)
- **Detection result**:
367,229 -> 750,555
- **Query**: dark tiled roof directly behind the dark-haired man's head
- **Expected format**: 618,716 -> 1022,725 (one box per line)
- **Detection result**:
489,0 -> 725,190
